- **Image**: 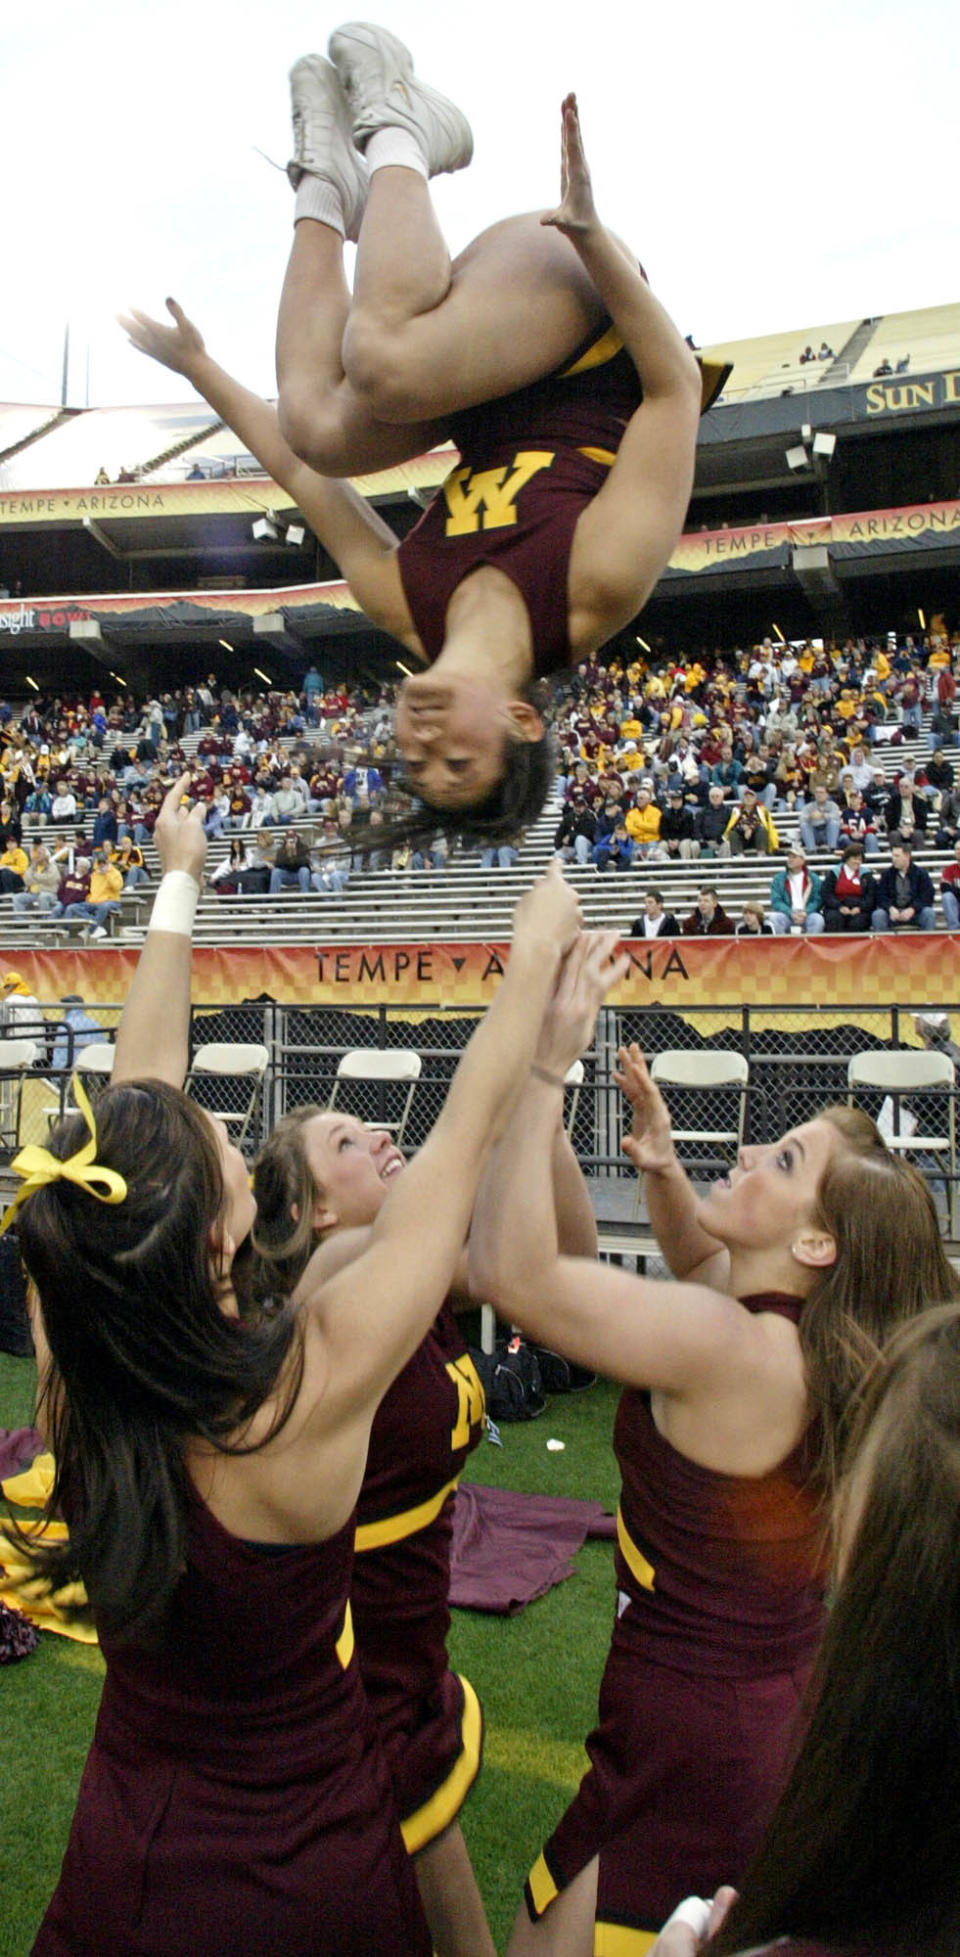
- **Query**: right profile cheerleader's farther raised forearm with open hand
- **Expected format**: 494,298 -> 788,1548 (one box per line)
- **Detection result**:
614,1045 -> 729,1292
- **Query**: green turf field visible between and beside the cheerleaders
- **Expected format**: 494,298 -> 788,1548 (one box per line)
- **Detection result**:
0,1354 -> 618,1957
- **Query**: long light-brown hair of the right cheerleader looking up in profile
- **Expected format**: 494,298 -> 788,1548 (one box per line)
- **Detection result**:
800,1106 -> 960,1491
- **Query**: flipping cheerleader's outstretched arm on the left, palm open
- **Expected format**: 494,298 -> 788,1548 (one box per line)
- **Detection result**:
119,299 -> 411,640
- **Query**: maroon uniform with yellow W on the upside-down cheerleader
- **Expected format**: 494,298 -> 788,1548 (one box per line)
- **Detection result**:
397,327 -> 643,679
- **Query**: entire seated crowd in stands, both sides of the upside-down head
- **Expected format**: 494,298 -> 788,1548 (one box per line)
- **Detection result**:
0,620 -> 960,937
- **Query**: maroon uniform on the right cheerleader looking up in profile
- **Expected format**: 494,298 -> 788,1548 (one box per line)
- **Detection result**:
526,1294 -> 825,1953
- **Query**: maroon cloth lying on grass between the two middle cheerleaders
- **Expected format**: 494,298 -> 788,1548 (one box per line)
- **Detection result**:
450,1481 -> 616,1616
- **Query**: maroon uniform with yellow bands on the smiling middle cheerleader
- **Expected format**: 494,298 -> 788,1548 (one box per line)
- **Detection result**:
350,1303 -> 485,1855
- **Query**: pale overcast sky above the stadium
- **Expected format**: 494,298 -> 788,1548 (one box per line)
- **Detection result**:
0,0 -> 960,407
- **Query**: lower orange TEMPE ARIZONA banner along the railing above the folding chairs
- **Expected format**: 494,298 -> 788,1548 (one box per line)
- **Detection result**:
4,932 -> 960,1012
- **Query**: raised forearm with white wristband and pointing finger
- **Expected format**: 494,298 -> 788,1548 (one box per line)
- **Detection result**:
109,775 -> 207,1088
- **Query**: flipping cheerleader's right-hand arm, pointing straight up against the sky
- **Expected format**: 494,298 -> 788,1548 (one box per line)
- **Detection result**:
544,96 -> 702,650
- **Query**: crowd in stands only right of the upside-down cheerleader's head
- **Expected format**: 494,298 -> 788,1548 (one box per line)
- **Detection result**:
553,622 -> 960,937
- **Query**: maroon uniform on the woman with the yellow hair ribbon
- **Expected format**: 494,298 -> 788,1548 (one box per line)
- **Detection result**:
33,1497 -> 430,1957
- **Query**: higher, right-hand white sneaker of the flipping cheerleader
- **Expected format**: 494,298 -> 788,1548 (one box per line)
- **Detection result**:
327,20 -> 473,176
